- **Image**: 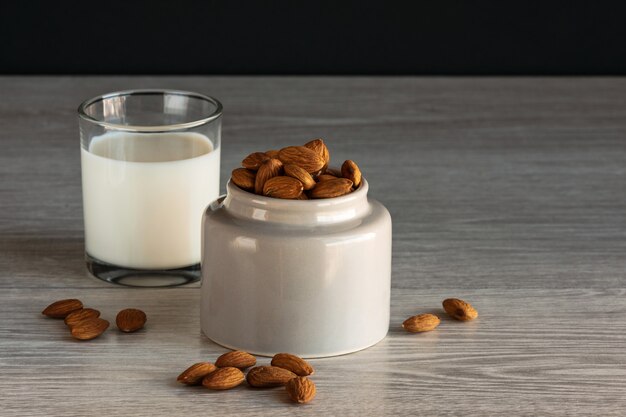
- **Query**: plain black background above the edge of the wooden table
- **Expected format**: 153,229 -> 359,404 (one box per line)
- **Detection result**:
0,0 -> 626,75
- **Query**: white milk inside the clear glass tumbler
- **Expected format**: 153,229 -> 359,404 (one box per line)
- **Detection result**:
81,132 -> 220,269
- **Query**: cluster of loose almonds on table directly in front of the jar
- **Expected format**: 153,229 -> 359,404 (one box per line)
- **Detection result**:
177,350 -> 316,404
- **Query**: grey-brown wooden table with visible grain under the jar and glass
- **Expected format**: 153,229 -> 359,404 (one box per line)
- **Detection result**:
0,77 -> 626,416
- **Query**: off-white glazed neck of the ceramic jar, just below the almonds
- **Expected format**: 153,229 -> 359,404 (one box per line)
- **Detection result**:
223,179 -> 370,227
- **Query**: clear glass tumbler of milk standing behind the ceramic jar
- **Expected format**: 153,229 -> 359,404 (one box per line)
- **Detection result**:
78,90 -> 222,286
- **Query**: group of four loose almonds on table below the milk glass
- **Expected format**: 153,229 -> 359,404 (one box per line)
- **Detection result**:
41,298 -> 147,340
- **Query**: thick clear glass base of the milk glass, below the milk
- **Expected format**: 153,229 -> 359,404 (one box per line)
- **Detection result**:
85,254 -> 201,287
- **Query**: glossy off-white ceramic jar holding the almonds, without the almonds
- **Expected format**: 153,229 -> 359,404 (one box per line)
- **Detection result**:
201,180 -> 391,358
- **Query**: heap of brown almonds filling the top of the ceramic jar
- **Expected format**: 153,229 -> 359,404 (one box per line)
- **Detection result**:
231,139 -> 361,200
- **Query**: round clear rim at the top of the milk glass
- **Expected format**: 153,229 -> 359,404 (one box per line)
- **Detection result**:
78,89 -> 223,132
